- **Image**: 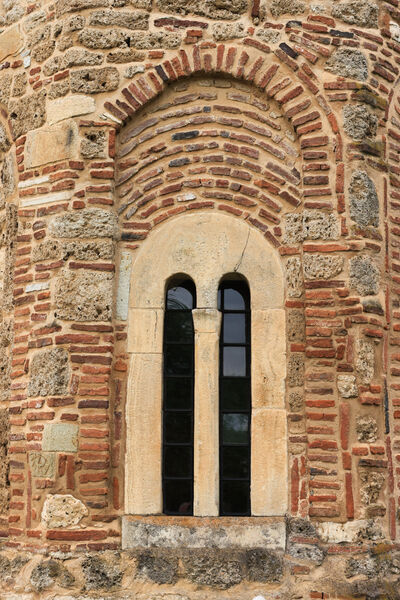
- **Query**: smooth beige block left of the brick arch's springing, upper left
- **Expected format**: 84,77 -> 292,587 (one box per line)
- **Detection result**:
25,121 -> 79,168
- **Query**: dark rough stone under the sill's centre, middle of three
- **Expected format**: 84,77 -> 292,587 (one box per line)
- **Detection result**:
183,551 -> 243,590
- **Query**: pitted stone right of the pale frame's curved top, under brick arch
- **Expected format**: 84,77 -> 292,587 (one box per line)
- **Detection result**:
284,210 -> 339,244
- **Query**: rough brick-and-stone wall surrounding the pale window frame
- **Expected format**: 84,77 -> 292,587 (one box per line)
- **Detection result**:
0,0 -> 400,600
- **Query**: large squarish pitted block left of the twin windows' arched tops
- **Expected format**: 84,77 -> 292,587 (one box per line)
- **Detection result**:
55,271 -> 113,321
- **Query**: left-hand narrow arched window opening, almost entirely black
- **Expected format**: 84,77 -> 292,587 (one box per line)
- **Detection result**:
162,278 -> 196,515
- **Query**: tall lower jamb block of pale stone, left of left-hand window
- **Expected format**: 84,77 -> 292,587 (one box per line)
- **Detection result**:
125,354 -> 162,515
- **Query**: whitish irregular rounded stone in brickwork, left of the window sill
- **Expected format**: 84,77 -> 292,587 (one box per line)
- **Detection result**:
42,494 -> 88,529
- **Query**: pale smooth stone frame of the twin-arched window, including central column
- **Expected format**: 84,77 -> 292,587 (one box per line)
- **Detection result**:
124,212 -> 288,519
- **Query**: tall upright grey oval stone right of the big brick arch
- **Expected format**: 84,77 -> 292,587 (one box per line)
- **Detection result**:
349,170 -> 379,227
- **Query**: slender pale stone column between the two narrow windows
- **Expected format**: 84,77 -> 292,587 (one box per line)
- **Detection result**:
192,308 -> 221,517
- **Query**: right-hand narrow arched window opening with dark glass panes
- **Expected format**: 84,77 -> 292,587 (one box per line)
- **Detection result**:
218,278 -> 251,515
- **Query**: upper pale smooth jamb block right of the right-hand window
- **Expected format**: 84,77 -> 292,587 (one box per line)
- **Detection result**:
251,309 -> 286,408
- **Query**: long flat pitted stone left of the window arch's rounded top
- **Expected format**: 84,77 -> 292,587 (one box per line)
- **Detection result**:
49,208 -> 117,238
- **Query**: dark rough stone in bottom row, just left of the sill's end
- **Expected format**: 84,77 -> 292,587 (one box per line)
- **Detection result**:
82,555 -> 122,590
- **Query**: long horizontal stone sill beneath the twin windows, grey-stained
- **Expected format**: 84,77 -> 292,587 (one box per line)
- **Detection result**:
122,515 -> 286,550
